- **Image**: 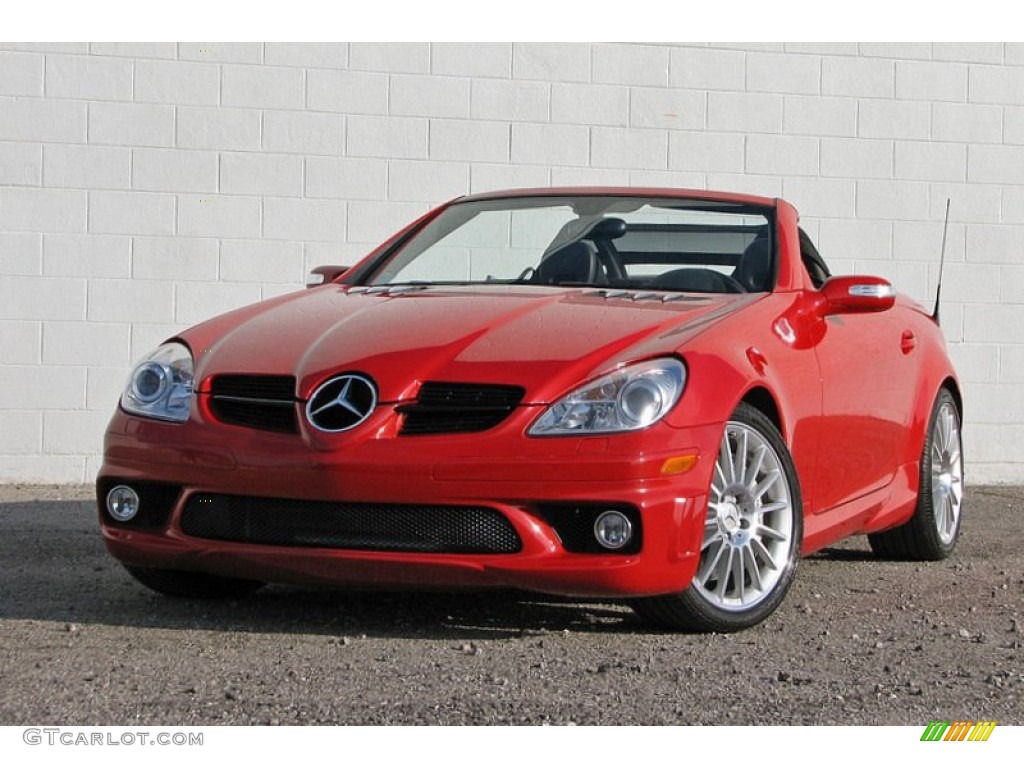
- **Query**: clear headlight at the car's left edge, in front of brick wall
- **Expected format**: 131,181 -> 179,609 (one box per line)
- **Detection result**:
121,342 -> 194,422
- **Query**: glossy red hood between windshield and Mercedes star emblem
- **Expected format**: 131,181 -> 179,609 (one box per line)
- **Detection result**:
180,285 -> 761,403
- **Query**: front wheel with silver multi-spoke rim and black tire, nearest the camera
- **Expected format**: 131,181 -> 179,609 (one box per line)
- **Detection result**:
632,402 -> 803,632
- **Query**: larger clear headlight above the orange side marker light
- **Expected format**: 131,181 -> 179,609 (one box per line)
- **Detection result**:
527,357 -> 686,436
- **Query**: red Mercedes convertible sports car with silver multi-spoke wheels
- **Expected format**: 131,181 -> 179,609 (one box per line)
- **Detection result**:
97,188 -> 964,631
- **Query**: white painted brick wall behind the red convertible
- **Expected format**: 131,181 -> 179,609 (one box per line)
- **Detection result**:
0,43 -> 1024,482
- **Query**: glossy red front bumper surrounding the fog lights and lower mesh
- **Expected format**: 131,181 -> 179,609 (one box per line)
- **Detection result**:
99,411 -> 721,598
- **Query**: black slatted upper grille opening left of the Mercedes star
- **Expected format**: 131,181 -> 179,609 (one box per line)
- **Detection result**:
210,374 -> 299,434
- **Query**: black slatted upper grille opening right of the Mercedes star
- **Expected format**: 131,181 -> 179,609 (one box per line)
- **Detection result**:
395,382 -> 526,435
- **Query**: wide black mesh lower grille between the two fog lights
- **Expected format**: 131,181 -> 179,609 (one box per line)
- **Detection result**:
181,494 -> 522,554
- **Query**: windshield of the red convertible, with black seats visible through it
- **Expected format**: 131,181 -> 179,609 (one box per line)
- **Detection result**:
365,196 -> 775,293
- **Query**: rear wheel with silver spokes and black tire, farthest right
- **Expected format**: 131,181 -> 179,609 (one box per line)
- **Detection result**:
867,388 -> 964,560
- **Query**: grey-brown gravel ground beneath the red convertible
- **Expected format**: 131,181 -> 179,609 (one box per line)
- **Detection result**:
0,485 -> 1024,725
